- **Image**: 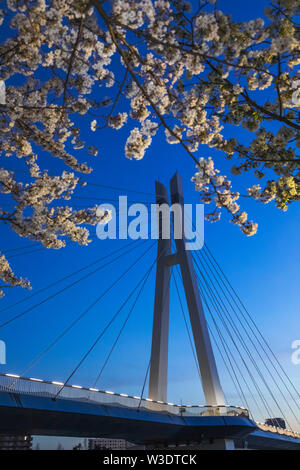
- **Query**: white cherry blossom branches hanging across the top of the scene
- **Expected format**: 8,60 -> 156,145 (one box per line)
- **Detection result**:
0,0 -> 300,292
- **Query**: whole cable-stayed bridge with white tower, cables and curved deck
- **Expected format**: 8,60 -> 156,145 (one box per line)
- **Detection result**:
0,174 -> 300,449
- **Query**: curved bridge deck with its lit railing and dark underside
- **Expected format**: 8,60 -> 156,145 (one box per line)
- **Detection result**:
0,374 -> 300,449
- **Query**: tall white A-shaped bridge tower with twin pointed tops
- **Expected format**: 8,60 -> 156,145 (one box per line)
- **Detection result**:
149,173 -> 225,406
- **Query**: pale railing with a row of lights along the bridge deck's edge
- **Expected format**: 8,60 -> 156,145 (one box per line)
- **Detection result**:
0,374 -> 249,417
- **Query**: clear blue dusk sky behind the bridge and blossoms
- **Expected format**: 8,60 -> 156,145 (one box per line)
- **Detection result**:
0,0 -> 300,445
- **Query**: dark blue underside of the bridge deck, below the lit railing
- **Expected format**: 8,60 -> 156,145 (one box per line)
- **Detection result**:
0,392 -> 256,444
